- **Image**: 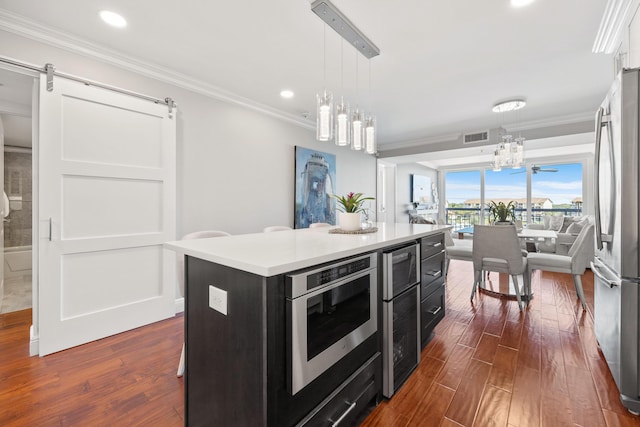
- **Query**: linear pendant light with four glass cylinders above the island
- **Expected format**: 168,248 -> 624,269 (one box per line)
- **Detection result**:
311,0 -> 380,154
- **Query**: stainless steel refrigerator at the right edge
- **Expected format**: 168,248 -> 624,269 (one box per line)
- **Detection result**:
591,69 -> 640,414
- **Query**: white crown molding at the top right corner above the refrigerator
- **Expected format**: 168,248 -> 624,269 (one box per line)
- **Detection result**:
591,0 -> 639,54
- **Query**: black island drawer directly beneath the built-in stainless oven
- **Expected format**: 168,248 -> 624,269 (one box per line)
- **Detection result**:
297,353 -> 380,427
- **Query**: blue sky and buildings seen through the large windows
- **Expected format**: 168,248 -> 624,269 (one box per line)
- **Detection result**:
445,163 -> 582,229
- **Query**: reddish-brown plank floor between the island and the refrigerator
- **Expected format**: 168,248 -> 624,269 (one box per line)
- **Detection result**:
362,261 -> 640,427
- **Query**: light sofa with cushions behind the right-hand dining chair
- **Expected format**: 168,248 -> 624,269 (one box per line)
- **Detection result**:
527,215 -> 594,255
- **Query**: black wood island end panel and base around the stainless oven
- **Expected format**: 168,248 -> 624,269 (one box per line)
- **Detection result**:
185,257 -> 382,427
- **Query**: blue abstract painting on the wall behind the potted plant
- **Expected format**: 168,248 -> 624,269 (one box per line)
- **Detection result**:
295,146 -> 336,228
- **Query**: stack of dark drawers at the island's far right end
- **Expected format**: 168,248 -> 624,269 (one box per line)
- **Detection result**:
420,233 -> 445,348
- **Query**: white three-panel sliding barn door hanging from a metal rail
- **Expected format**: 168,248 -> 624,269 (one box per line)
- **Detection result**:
38,78 -> 176,356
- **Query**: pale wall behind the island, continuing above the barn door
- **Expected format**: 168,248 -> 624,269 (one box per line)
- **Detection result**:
0,31 -> 376,236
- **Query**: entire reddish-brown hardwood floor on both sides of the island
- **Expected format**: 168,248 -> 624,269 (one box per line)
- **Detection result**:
0,261 -> 640,427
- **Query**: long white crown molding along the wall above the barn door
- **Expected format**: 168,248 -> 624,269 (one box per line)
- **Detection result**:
0,10 -> 315,130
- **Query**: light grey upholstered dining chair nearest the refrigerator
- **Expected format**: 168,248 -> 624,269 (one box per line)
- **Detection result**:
527,224 -> 595,310
